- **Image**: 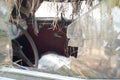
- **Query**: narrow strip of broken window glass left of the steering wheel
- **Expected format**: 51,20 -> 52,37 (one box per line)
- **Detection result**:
0,0 -> 12,66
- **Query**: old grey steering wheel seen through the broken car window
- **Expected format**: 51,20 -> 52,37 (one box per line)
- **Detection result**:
12,23 -> 39,68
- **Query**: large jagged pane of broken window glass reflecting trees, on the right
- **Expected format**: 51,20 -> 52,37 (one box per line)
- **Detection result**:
67,2 -> 120,78
